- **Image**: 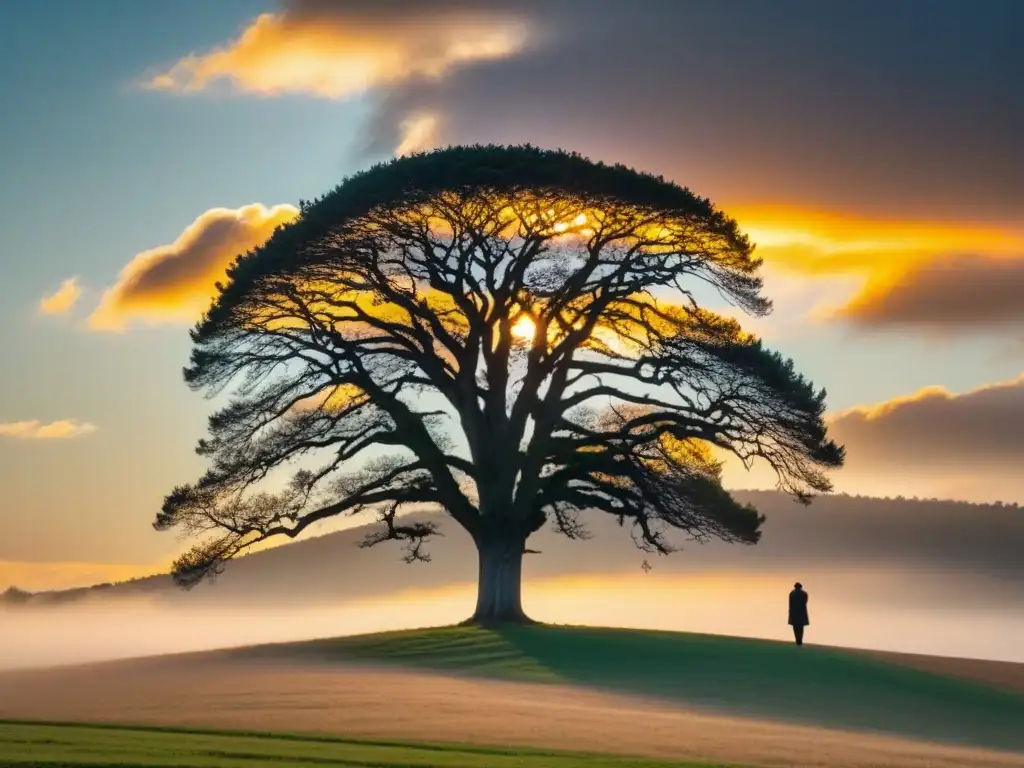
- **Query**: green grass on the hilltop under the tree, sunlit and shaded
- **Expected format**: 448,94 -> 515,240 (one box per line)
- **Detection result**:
237,627 -> 1024,751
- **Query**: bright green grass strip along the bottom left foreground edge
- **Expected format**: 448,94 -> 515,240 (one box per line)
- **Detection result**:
0,722 -> 741,768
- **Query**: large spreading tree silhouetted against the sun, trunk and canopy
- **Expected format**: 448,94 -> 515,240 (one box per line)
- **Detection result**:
155,146 -> 843,624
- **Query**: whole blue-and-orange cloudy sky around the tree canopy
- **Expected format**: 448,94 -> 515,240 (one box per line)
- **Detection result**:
0,0 -> 1024,584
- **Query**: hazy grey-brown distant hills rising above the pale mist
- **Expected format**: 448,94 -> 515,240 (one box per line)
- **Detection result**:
0,490 -> 1024,607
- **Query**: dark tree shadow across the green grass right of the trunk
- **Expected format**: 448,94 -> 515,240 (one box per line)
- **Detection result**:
495,627 -> 1024,751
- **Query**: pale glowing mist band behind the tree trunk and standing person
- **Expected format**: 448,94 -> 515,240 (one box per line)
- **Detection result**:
8,565 -> 1024,670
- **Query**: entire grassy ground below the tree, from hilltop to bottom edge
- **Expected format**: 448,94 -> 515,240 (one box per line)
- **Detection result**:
0,627 -> 1024,768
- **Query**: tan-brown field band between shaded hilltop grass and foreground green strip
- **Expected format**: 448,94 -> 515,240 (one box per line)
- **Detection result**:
0,654 -> 1024,768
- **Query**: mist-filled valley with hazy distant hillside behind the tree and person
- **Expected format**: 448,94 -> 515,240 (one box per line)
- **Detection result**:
0,493 -> 1024,669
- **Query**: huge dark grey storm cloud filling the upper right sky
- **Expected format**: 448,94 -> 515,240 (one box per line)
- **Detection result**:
344,0 -> 1024,221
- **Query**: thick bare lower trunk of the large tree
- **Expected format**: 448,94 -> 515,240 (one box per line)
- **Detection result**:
466,535 -> 530,627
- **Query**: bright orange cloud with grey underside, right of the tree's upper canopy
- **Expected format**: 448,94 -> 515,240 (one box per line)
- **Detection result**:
726,206 -> 1024,329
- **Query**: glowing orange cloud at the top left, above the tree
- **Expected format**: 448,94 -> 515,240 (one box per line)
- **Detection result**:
145,6 -> 527,98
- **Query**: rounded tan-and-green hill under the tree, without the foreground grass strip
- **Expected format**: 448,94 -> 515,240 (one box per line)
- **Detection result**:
0,626 -> 1024,766
